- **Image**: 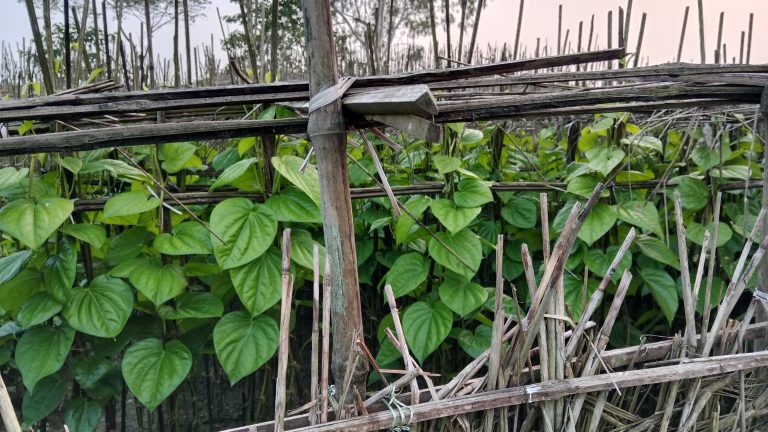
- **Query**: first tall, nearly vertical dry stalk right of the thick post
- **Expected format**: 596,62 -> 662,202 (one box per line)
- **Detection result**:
483,234 -> 504,432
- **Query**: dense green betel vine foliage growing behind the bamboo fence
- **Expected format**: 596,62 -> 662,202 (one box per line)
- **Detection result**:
0,107 -> 763,431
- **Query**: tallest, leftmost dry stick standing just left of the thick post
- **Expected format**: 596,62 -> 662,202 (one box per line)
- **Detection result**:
275,228 -> 293,432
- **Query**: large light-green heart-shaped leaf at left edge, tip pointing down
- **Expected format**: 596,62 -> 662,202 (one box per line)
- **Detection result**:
0,197 -> 74,249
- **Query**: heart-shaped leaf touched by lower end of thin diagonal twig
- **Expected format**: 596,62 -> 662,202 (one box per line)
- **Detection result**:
429,229 -> 483,279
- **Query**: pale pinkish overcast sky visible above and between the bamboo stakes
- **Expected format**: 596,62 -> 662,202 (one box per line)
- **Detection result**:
0,0 -> 768,69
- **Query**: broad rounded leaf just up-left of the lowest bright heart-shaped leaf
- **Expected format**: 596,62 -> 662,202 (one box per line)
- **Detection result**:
64,275 -> 133,338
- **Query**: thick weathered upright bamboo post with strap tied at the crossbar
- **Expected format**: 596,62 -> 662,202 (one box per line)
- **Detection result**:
302,0 -> 368,402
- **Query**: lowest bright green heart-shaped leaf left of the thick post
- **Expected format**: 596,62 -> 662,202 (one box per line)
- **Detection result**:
123,338 -> 192,411
